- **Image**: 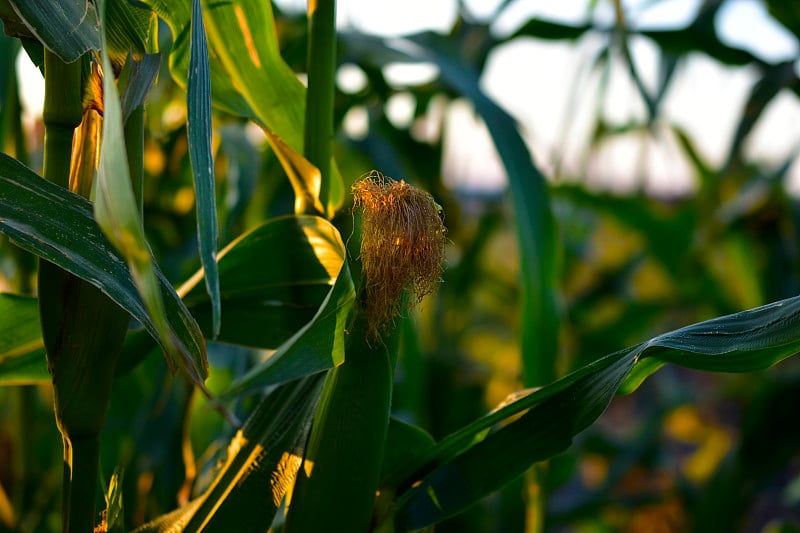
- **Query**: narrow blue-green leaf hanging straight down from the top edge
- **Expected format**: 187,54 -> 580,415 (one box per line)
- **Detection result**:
186,0 -> 222,338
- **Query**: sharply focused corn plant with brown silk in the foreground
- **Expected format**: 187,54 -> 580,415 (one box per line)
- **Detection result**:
0,0 -> 800,532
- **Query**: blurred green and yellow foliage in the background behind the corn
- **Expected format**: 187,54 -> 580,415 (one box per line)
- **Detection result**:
0,0 -> 800,532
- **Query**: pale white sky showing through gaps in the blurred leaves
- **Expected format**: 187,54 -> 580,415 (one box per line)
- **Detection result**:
18,0 -> 800,194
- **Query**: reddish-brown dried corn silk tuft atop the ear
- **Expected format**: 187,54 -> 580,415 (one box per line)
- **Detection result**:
353,171 -> 447,337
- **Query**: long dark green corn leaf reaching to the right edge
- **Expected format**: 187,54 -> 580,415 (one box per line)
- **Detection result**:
383,297 -> 800,530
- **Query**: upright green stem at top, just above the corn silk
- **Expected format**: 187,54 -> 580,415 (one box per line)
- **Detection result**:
303,0 -> 336,214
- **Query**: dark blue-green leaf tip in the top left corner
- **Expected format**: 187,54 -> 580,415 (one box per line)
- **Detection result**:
9,0 -> 100,63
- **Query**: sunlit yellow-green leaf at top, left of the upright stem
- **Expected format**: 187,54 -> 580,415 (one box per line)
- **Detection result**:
141,0 -> 345,215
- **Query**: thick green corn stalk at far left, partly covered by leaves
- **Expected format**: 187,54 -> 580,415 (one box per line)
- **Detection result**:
39,50 -> 108,533
